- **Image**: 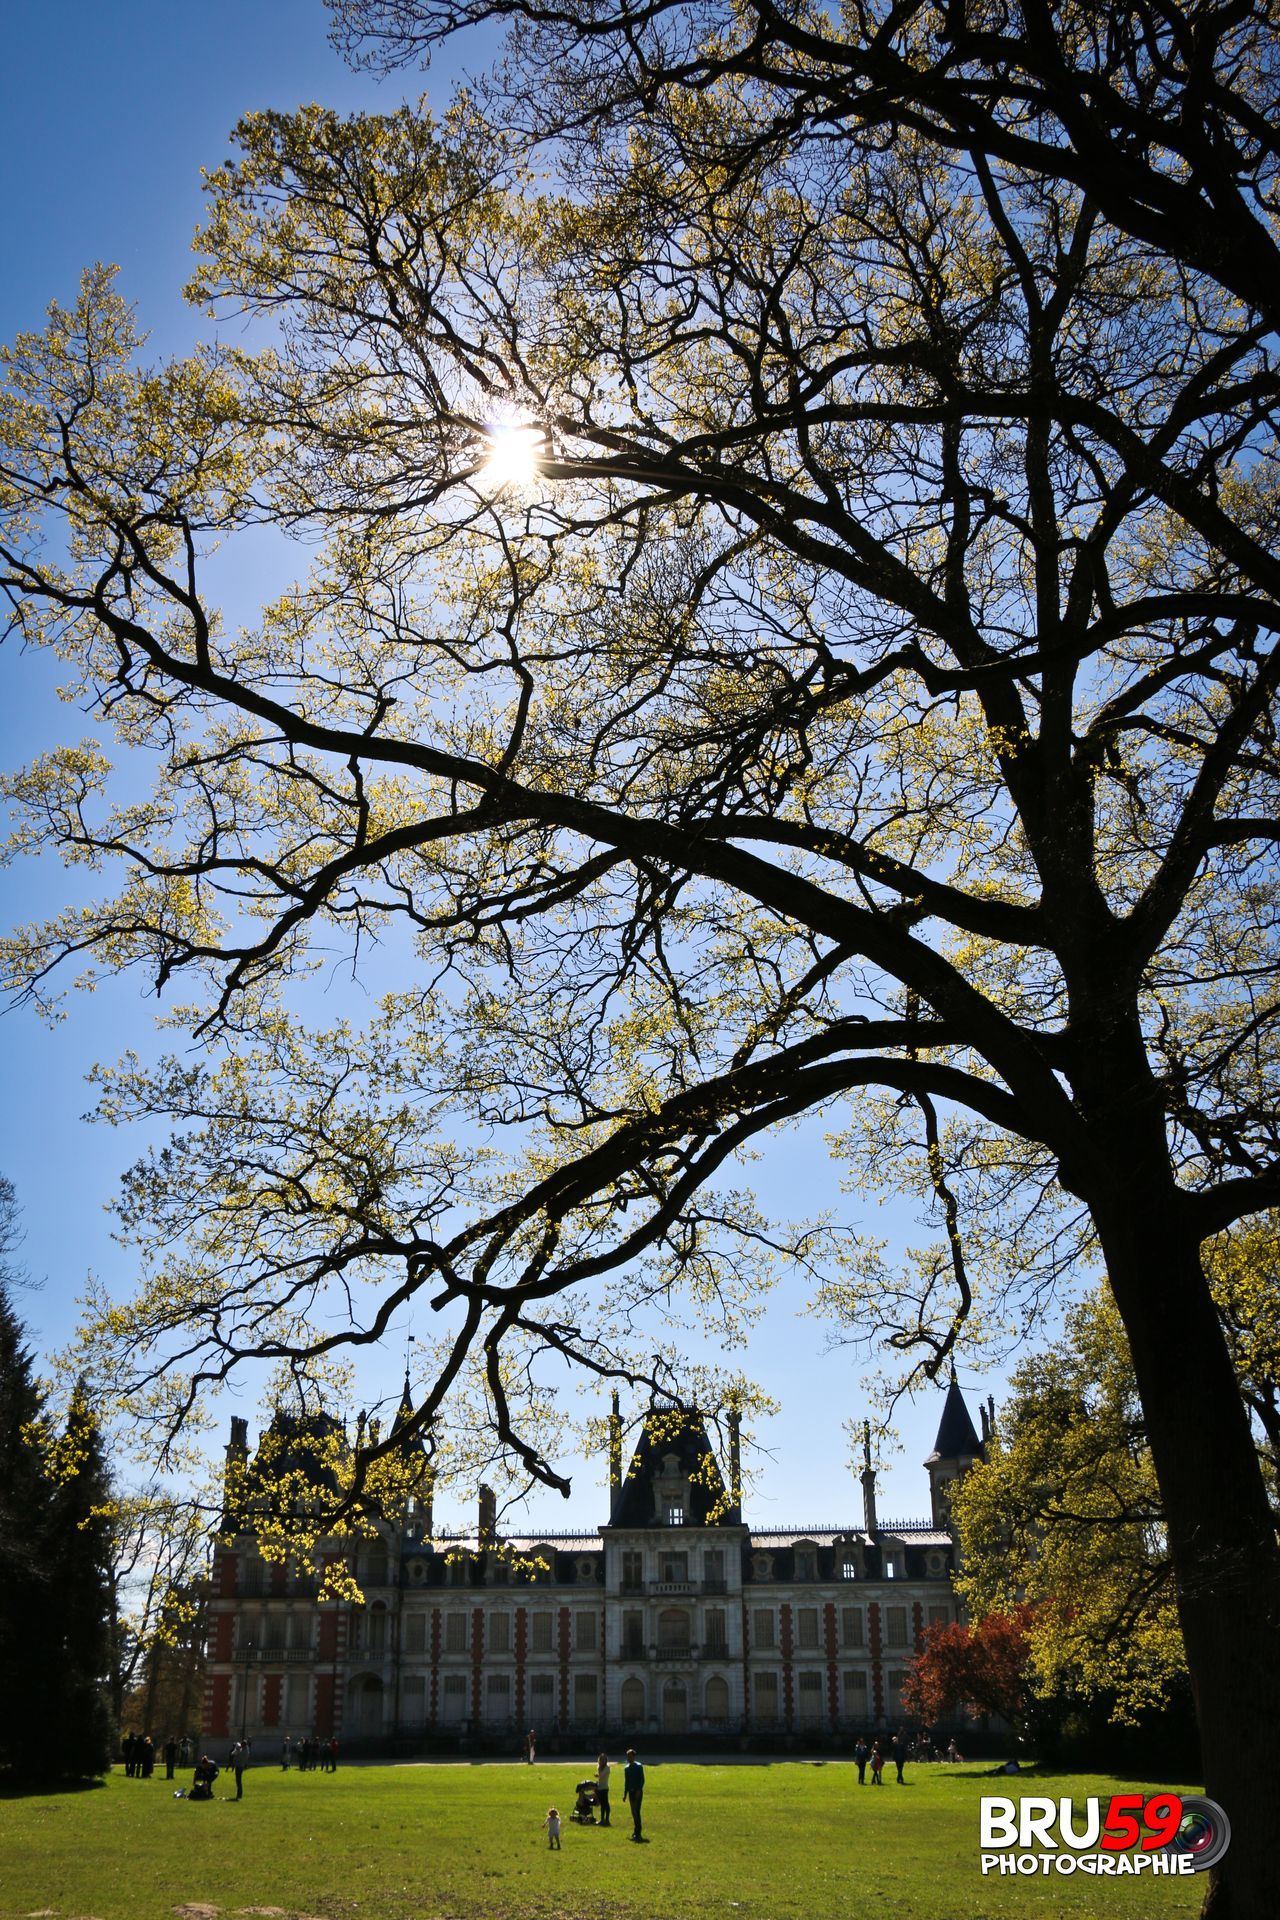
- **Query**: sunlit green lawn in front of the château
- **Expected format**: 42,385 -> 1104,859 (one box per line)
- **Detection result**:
0,1761 -> 1203,1920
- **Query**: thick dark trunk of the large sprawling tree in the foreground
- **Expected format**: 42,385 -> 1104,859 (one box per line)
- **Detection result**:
1090,1110 -> 1280,1920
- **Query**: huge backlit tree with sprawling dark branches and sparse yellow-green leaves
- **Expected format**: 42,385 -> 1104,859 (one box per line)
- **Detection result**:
0,0 -> 1280,1916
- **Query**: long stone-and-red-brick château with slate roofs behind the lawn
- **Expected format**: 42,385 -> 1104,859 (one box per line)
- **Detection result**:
203,1382 -> 988,1757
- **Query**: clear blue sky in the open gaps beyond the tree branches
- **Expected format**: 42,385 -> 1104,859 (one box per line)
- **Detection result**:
0,0 -> 1020,1526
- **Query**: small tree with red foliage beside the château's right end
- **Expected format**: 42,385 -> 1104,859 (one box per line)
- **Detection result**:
902,1603 -> 1044,1736
